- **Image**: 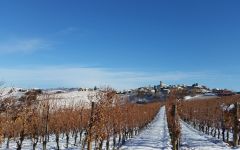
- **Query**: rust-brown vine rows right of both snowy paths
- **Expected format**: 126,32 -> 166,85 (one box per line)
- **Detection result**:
178,95 -> 240,147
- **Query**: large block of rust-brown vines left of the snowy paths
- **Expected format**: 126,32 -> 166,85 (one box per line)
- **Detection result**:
0,89 -> 161,150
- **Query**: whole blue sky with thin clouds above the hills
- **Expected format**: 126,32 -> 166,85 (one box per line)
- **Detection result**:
0,0 -> 240,90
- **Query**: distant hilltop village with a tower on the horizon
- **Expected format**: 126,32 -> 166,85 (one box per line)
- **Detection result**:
121,81 -> 236,103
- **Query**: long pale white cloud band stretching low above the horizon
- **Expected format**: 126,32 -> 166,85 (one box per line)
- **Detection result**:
0,66 -> 219,89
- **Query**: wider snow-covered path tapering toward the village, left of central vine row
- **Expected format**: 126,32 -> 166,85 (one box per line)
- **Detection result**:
120,106 -> 172,150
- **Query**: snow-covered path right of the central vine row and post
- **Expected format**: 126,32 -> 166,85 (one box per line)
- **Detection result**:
181,121 -> 231,150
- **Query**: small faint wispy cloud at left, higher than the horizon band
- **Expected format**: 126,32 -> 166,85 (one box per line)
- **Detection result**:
0,38 -> 50,53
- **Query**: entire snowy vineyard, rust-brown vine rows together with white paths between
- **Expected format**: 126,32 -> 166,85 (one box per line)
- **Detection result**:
0,88 -> 240,150
